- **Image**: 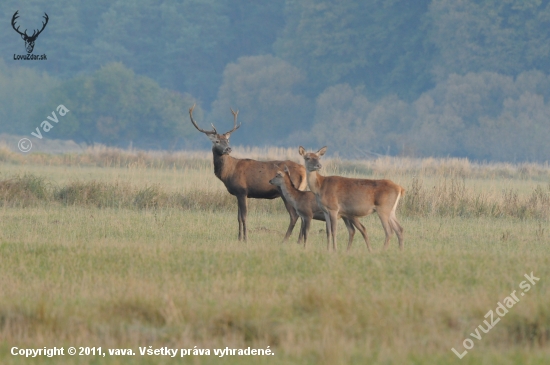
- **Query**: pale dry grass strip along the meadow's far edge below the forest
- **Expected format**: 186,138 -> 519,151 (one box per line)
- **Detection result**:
0,145 -> 550,180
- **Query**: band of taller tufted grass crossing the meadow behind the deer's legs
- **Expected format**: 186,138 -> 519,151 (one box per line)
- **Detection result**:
0,171 -> 550,219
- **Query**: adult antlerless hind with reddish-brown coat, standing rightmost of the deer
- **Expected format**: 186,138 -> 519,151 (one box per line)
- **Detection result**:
299,146 -> 405,252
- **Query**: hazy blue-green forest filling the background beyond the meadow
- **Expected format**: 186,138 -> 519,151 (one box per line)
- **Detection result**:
0,0 -> 550,162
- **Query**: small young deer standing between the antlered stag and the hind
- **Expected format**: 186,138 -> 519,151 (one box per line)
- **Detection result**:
269,166 -> 367,247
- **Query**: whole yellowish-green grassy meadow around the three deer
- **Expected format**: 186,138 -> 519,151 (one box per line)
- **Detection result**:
0,144 -> 550,365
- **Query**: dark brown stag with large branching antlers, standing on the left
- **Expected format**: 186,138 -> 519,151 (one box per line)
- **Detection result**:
189,105 -> 307,241
